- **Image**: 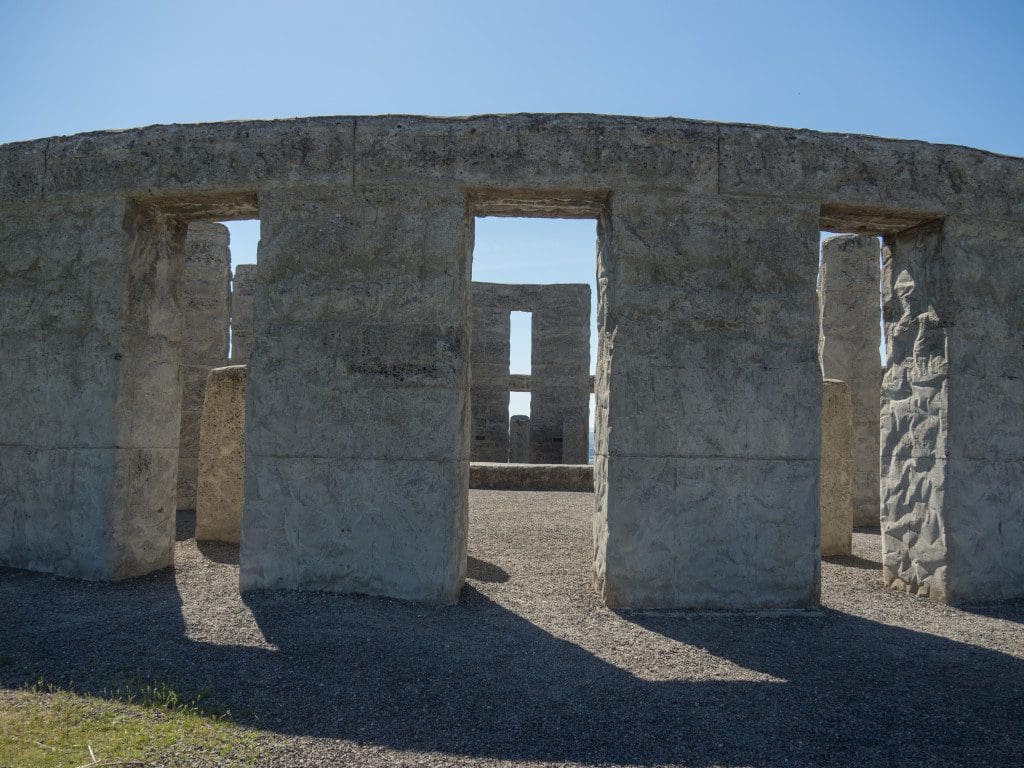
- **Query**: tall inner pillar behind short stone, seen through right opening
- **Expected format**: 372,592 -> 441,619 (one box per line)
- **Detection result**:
818,234 -> 882,525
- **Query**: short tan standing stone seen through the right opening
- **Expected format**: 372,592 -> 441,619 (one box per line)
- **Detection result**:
821,379 -> 854,557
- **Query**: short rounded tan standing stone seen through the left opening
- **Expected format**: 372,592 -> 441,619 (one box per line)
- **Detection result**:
196,366 -> 246,544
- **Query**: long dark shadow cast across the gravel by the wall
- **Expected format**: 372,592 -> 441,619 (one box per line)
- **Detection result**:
0,569 -> 1024,768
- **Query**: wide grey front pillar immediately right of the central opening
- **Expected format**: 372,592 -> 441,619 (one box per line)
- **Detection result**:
594,191 -> 821,609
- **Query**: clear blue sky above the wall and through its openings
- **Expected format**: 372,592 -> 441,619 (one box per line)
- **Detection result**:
0,0 -> 1024,421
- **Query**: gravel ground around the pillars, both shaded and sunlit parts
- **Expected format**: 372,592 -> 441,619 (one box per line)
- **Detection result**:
0,492 -> 1024,767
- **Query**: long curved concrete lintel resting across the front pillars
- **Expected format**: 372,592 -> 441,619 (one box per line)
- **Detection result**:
0,114 -> 1024,225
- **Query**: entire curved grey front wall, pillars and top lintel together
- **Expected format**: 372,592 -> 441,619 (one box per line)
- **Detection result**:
0,115 -> 1024,609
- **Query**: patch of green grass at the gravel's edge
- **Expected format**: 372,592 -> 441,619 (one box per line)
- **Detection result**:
0,682 -> 258,768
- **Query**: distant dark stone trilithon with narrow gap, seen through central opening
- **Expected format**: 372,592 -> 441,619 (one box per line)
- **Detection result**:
472,282 -> 590,464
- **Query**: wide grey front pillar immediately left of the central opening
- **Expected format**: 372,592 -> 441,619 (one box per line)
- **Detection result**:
240,187 -> 472,602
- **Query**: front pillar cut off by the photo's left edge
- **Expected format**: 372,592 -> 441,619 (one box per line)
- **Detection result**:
0,200 -> 185,580
